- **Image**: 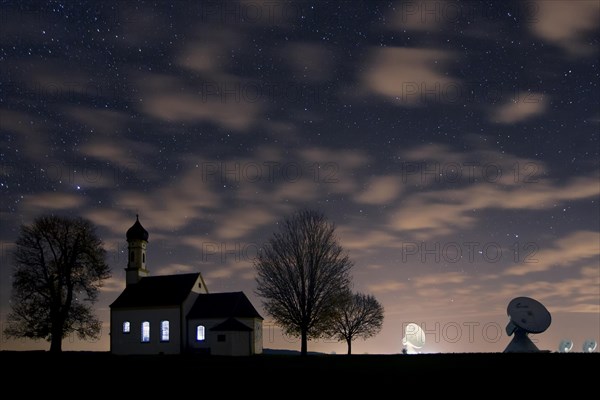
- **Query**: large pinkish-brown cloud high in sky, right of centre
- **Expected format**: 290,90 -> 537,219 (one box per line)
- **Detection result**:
362,47 -> 459,106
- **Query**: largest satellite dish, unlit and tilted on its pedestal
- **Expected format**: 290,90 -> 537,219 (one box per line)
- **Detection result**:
504,297 -> 552,353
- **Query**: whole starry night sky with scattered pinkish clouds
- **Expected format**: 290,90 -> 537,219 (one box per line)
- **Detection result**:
0,0 -> 600,353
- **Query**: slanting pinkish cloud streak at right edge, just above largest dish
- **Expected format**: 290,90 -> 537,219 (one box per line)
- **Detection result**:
505,231 -> 600,276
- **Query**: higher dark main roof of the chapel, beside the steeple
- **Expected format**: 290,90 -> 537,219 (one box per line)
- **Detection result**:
110,273 -> 200,308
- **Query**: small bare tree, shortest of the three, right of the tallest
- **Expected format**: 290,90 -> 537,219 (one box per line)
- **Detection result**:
330,291 -> 383,354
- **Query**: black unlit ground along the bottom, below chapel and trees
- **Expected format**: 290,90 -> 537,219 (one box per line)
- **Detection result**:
0,351 -> 600,392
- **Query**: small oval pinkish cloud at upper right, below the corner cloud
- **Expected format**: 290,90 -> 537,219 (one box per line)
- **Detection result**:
490,92 -> 548,124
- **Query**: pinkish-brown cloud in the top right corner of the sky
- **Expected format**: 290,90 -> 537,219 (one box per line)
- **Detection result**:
530,0 -> 600,56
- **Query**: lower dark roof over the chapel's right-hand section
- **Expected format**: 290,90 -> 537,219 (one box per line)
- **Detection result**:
188,292 -> 263,319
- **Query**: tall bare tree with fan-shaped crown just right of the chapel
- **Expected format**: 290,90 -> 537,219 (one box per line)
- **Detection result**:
254,210 -> 352,355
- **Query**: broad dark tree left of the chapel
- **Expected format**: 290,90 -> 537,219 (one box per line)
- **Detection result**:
4,216 -> 110,352
